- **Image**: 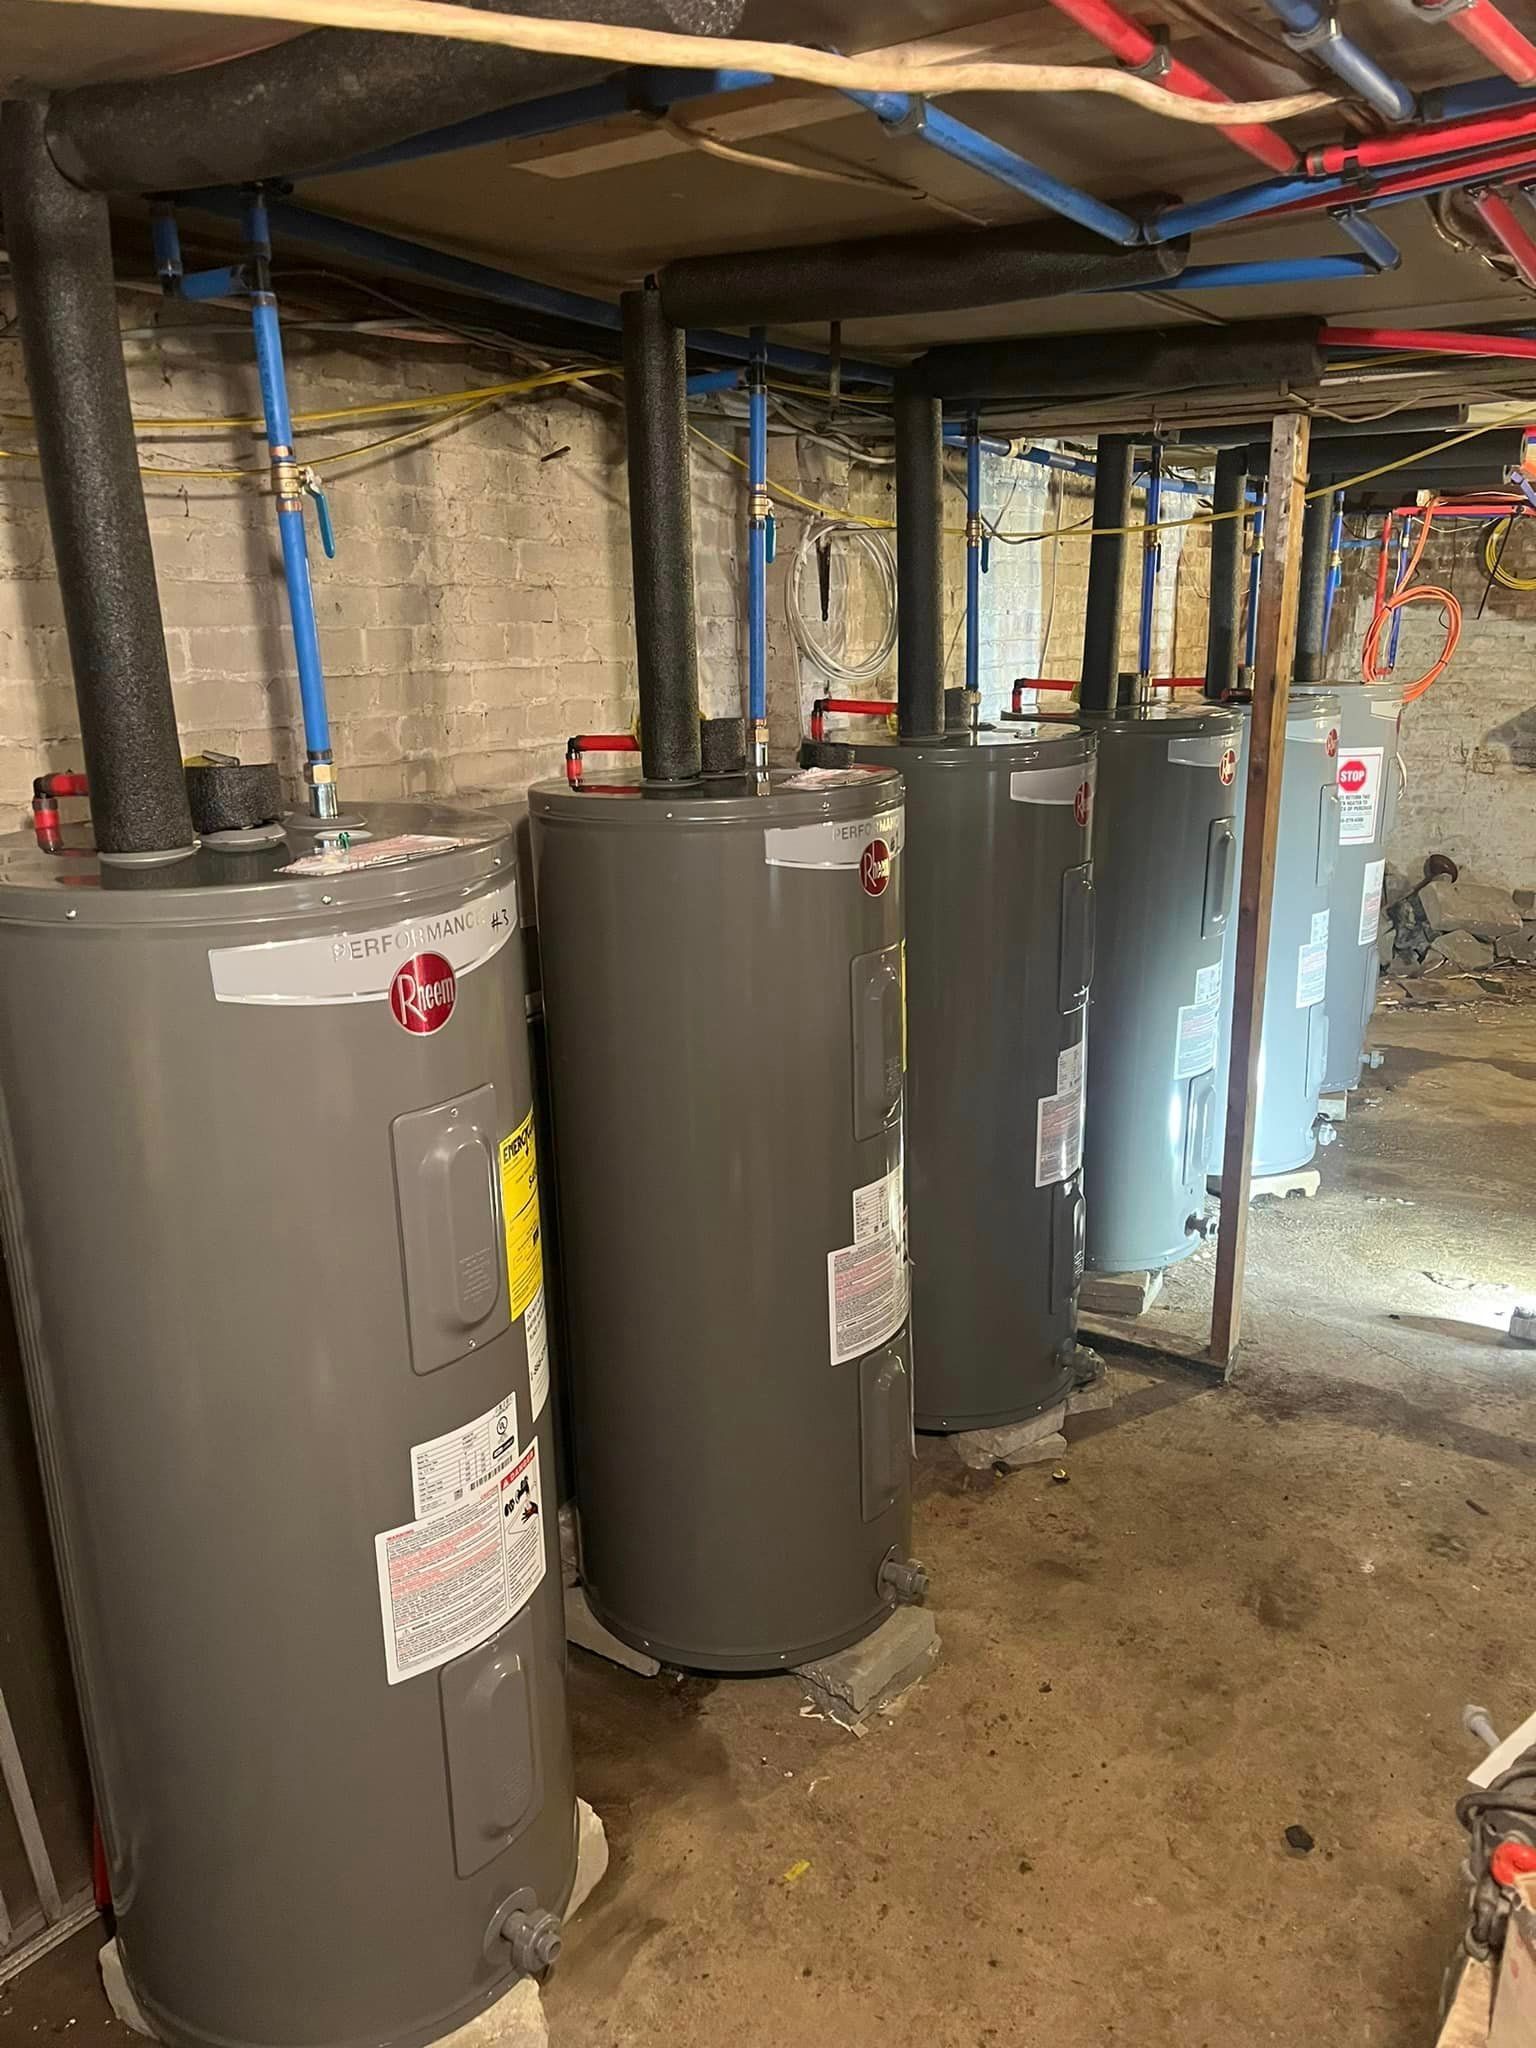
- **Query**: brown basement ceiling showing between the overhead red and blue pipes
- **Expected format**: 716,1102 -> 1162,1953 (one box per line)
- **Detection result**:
0,0 -> 1536,381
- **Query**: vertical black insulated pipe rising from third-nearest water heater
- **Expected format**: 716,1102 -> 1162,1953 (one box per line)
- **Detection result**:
895,377 -> 944,739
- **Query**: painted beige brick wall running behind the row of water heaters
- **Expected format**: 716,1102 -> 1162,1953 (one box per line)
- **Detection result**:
0,295 -> 1204,825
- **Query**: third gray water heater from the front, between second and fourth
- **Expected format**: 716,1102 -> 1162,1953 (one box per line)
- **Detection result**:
856,725 -> 1094,1430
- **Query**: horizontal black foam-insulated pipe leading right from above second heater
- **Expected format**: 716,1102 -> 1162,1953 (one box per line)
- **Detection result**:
657,221 -> 1190,328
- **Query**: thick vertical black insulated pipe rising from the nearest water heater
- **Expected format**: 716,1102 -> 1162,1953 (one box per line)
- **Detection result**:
0,100 -> 193,856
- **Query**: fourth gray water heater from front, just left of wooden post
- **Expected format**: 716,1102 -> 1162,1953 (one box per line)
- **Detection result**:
1056,705 -> 1237,1272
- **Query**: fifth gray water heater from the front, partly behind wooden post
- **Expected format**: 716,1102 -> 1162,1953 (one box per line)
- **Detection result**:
1210,690 -> 1343,1182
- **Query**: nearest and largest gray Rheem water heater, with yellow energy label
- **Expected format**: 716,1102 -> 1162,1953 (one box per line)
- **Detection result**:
0,807 -> 575,2048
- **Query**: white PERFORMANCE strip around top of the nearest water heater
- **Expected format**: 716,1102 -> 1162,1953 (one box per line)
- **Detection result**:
209,877 -> 518,1006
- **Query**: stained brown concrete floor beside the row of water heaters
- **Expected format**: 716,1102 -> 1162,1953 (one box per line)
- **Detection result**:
12,977 -> 1536,2048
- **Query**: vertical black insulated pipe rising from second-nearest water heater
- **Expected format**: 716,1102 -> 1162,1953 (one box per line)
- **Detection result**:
618,285 -> 702,782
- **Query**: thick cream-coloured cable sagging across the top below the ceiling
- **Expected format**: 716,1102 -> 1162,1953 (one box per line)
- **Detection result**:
30,0 -> 1337,127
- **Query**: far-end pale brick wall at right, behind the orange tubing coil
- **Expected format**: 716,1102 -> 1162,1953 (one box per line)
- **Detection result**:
1329,522 -> 1536,887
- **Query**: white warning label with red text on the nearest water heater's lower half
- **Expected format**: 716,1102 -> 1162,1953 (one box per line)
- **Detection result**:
373,1397 -> 545,1686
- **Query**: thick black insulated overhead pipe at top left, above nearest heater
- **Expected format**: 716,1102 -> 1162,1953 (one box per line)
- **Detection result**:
47,0 -> 741,193
